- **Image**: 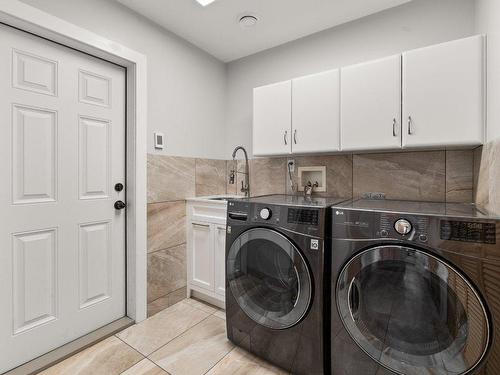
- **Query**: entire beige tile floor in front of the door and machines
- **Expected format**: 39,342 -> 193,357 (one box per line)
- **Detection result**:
42,299 -> 287,375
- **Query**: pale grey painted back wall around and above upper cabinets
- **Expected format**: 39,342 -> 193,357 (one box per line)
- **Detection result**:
226,0 -> 476,154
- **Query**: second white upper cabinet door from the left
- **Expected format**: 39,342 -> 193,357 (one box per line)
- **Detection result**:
292,69 -> 340,153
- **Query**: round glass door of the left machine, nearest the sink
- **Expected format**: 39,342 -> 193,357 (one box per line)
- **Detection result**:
227,228 -> 311,329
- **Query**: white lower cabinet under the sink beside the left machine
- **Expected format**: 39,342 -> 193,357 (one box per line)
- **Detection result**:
186,198 -> 227,307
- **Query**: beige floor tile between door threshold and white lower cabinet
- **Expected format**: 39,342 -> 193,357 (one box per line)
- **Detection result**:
117,302 -> 210,356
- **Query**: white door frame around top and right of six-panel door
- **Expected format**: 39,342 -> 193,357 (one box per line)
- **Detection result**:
0,0 -> 147,322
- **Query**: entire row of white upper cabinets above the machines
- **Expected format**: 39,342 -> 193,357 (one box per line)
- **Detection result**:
253,35 -> 486,156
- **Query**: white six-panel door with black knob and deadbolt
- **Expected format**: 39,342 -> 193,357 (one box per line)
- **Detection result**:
0,25 -> 125,373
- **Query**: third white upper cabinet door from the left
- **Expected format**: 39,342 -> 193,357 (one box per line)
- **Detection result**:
340,55 -> 401,150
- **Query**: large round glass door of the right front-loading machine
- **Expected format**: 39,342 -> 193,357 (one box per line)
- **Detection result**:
336,246 -> 490,375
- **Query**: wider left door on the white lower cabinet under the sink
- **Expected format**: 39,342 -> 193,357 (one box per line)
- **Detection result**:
190,223 -> 214,291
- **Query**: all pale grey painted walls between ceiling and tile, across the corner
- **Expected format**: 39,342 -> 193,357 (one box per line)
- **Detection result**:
22,0 -> 480,158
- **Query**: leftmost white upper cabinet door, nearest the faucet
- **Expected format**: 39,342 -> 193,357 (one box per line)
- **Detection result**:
253,81 -> 292,156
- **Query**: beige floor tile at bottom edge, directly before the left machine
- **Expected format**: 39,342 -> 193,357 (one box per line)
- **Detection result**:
207,348 -> 288,375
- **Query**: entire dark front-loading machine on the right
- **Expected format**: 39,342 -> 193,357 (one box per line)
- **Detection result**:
331,200 -> 500,375
